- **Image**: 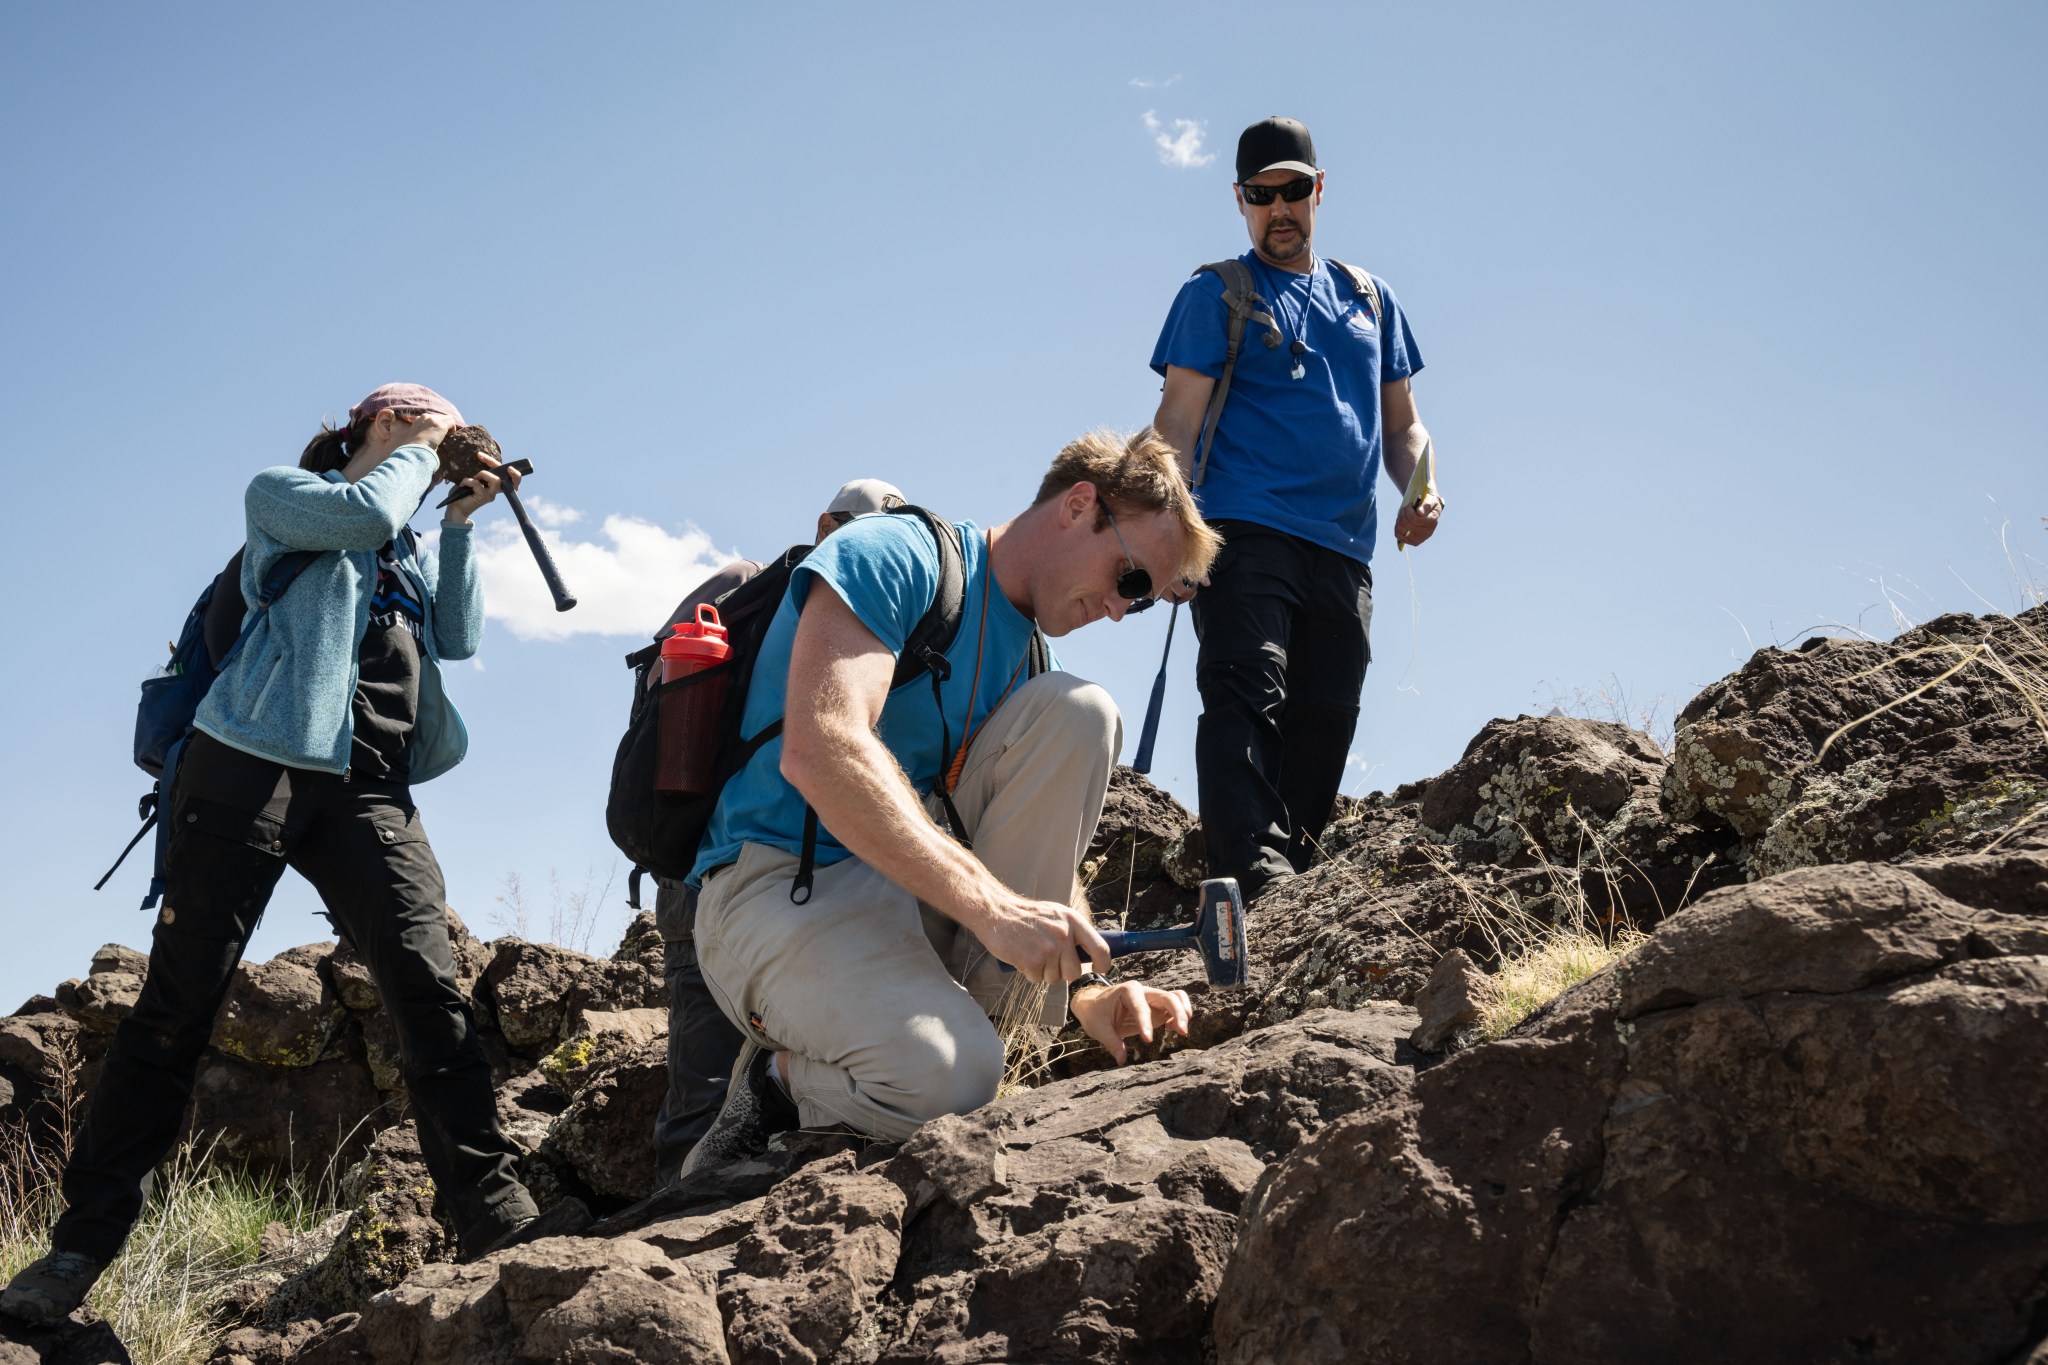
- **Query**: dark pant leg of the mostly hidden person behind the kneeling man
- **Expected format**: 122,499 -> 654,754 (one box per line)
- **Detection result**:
653,880 -> 745,1189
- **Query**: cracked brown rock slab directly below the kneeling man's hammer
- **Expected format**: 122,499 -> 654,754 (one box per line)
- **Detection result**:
696,1007 -> 1415,1363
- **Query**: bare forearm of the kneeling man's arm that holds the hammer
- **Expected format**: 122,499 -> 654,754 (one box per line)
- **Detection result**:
782,716 -> 1004,929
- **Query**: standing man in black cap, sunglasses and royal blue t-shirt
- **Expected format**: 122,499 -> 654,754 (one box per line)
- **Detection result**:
1151,117 -> 1444,900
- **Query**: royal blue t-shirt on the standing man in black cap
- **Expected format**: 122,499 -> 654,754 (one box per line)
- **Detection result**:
1151,252 -> 1421,561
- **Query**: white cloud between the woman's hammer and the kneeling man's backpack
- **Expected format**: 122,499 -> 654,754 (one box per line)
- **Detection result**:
477,507 -> 739,641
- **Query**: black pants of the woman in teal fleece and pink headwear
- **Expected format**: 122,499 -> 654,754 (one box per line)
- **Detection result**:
51,735 -> 535,1261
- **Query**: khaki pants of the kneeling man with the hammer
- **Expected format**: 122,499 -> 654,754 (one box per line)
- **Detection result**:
696,673 -> 1122,1140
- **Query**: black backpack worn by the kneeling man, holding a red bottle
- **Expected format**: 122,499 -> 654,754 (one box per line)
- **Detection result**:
604,508 -> 1003,909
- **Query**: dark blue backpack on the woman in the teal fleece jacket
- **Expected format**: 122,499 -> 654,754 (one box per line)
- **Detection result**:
92,528 -> 325,911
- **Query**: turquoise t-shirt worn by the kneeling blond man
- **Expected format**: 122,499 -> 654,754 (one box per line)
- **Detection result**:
688,516 -> 1032,886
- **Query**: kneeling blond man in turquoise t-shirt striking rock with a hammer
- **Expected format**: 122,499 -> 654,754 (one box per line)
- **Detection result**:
684,430 -> 1221,1173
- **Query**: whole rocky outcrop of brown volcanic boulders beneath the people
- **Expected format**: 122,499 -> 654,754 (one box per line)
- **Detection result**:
0,612 -> 2048,1365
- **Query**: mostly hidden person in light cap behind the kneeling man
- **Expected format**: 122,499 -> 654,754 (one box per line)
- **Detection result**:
647,479 -> 905,1189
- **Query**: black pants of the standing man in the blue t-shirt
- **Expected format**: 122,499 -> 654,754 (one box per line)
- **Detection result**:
1192,520 -> 1372,900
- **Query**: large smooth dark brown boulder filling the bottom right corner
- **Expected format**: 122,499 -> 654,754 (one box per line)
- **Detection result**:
1217,857 -> 2048,1365
